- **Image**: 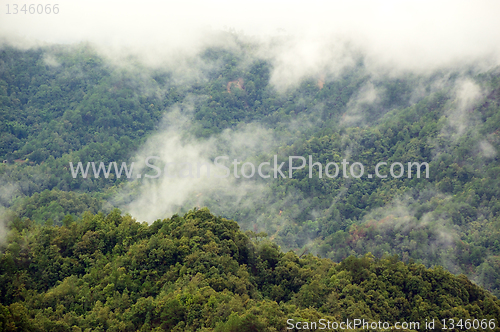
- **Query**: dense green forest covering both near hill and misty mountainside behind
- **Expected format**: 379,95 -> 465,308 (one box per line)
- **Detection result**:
0,36 -> 500,331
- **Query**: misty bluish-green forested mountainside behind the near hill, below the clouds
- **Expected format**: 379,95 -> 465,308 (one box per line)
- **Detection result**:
0,42 -> 500,296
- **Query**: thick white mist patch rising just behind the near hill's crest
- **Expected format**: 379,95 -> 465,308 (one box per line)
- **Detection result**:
112,105 -> 276,222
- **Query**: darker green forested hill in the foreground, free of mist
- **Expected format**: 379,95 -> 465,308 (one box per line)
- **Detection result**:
0,209 -> 500,331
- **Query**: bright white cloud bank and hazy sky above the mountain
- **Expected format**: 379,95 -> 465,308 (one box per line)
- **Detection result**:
0,0 -> 500,75
